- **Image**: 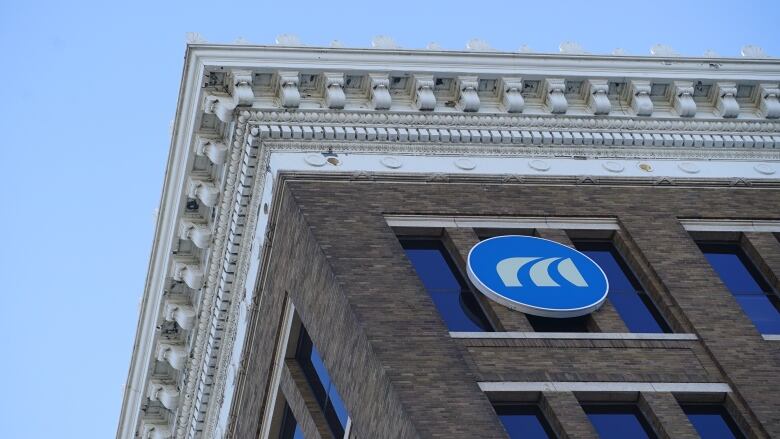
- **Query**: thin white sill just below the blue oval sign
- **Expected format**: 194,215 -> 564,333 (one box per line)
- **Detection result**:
450,331 -> 699,340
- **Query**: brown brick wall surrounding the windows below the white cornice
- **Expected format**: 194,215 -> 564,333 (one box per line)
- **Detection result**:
233,177 -> 780,438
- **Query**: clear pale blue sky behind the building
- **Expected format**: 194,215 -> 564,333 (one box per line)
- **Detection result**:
0,0 -> 780,439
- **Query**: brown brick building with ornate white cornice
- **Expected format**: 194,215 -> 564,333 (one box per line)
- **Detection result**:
118,44 -> 780,439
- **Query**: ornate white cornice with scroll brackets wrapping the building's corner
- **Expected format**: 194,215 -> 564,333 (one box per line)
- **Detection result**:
118,45 -> 780,438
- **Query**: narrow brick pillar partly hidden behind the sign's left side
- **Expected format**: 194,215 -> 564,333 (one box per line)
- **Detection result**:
444,227 -> 533,332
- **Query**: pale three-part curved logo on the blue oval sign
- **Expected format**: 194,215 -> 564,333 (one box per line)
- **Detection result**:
496,257 -> 588,287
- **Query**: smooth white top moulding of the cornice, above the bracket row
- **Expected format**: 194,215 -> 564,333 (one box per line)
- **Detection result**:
188,44 -> 780,82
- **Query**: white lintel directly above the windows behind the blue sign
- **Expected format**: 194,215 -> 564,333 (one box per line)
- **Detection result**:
385,215 -> 620,230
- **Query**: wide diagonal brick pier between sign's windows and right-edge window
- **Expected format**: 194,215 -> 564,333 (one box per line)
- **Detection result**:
620,215 -> 780,437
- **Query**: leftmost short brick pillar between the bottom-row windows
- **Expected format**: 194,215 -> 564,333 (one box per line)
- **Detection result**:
540,392 -> 599,439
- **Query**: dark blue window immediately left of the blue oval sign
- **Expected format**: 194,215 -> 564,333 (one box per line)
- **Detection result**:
401,239 -> 493,331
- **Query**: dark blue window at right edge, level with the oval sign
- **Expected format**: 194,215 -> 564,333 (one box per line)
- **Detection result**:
698,242 -> 780,334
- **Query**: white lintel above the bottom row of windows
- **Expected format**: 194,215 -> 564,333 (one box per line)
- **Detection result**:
477,381 -> 731,393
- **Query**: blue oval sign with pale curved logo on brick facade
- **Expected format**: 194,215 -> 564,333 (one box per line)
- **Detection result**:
468,235 -> 609,317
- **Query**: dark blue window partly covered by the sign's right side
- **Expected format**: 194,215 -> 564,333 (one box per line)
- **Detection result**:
575,241 -> 671,332
